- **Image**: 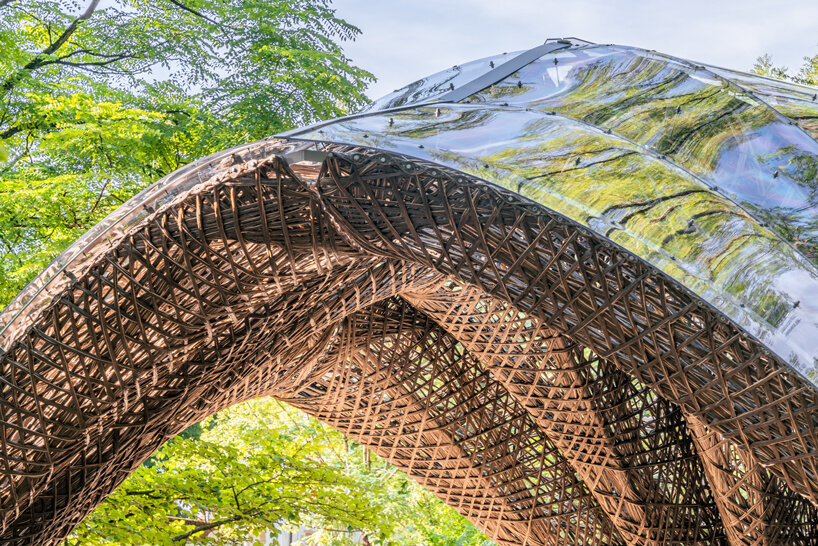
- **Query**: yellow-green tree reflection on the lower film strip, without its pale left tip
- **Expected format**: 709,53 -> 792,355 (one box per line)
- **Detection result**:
480,118 -> 789,323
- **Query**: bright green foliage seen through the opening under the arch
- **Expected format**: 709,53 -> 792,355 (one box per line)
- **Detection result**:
68,398 -> 491,546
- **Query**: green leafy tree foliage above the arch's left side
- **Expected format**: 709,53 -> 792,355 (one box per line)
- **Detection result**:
0,0 -> 372,303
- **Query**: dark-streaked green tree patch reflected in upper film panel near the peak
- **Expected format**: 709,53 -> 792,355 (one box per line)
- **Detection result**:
524,55 -> 775,169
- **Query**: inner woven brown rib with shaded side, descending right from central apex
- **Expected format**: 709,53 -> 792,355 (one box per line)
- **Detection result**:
410,283 -> 723,544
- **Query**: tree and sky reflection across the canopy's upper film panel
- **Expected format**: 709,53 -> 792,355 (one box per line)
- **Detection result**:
478,50 -> 818,263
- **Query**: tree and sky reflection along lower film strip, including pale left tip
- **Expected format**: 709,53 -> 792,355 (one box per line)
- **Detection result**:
330,106 -> 796,324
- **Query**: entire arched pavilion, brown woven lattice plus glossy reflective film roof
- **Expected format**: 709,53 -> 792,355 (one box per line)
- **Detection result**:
0,40 -> 818,545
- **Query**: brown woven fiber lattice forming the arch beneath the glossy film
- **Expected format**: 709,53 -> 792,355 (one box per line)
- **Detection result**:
0,142 -> 818,545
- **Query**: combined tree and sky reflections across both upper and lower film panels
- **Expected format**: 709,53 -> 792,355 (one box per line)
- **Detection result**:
332,48 -> 816,324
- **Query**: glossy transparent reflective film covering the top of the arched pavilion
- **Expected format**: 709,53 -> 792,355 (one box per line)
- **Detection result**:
289,42 -> 818,384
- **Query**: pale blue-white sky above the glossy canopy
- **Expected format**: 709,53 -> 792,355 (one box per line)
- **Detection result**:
333,0 -> 818,99
